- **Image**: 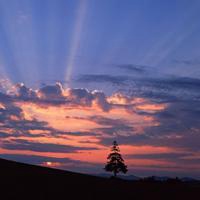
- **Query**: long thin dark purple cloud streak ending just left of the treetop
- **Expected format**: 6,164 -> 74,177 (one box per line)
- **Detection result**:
2,139 -> 97,153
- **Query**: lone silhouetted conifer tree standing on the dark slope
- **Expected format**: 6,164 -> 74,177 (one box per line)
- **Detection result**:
104,141 -> 128,177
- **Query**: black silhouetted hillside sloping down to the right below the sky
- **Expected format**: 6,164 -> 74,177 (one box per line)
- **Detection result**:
0,159 -> 200,200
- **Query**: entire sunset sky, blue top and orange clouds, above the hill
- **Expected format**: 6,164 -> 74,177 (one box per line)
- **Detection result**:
0,0 -> 200,178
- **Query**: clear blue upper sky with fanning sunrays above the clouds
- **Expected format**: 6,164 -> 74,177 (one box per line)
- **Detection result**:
0,0 -> 200,86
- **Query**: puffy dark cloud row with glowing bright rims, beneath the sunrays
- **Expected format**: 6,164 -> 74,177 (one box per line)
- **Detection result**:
3,83 -> 110,111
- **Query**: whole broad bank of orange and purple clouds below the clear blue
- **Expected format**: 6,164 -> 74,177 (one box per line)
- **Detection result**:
0,79 -> 200,175
